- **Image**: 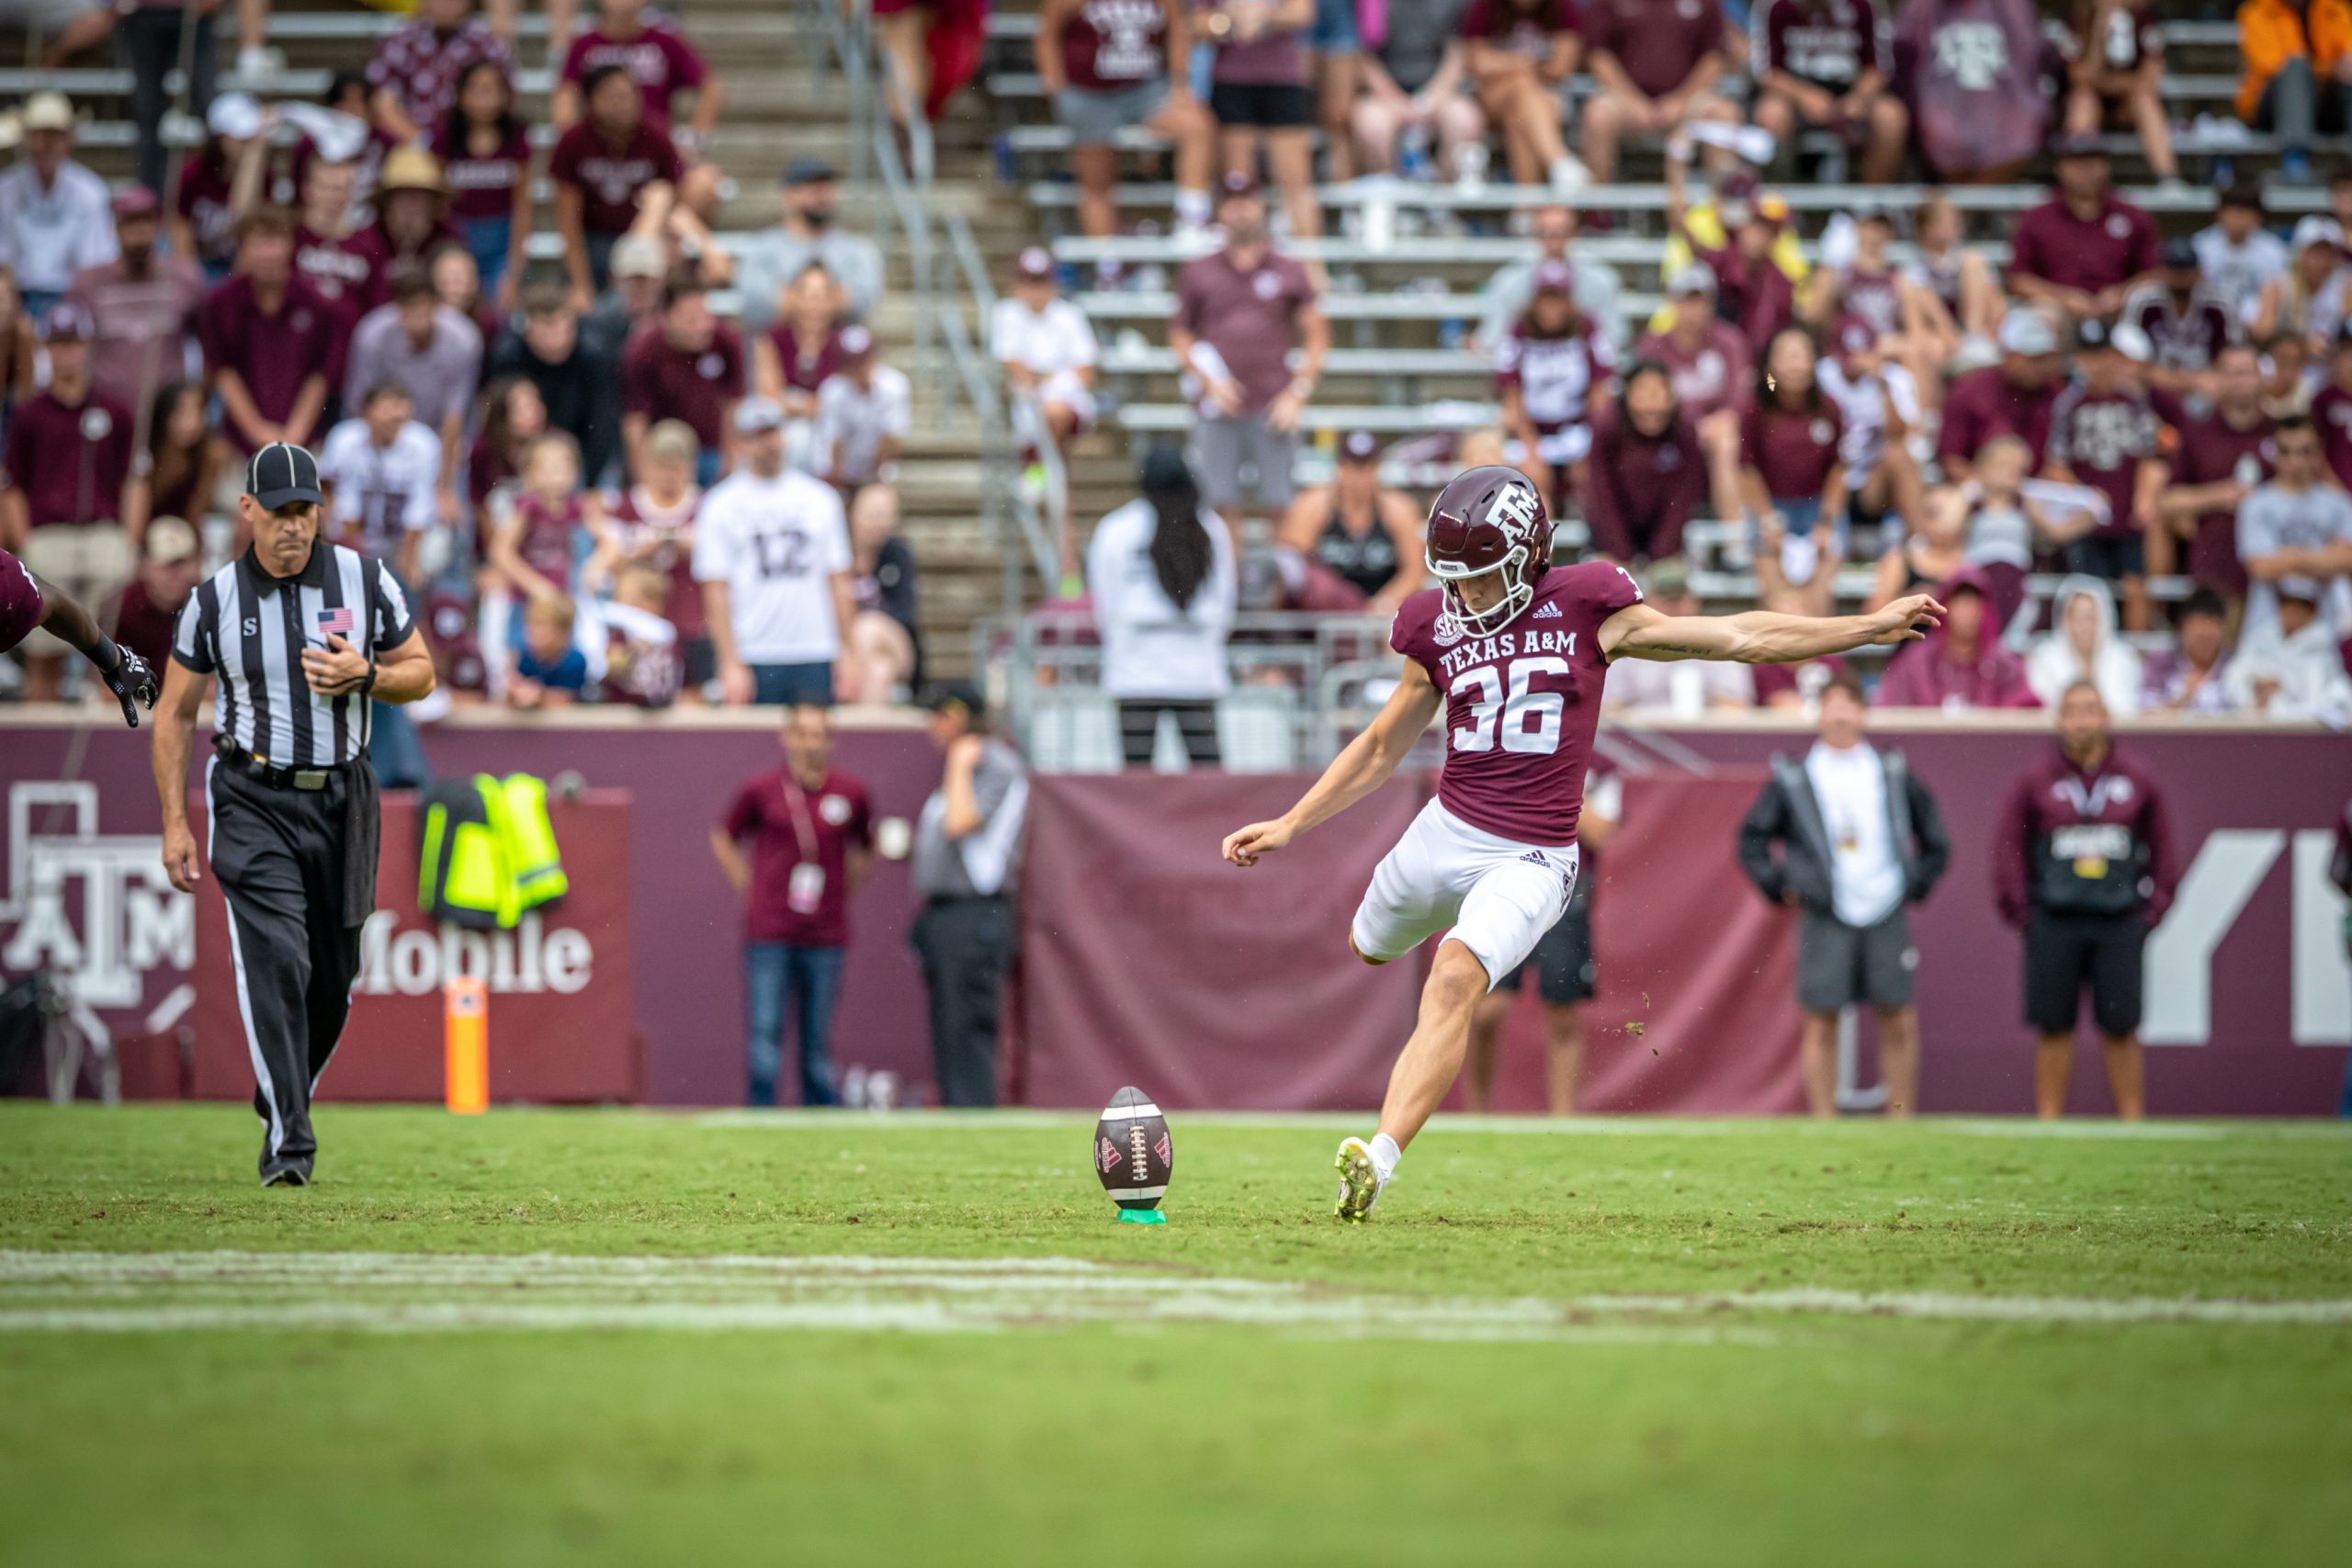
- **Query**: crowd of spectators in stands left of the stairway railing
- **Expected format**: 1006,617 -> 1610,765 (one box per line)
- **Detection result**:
0,0 -> 920,733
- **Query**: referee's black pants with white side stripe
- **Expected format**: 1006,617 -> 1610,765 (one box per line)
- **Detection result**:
205,761 -> 365,1170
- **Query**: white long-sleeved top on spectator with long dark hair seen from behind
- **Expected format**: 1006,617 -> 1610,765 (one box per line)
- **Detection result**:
1087,501 -> 1239,701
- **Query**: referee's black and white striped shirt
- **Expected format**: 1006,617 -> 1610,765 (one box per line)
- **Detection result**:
172,541 -> 414,769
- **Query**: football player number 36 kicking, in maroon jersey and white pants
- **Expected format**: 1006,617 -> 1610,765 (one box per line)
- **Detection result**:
1226,468 -> 1943,1220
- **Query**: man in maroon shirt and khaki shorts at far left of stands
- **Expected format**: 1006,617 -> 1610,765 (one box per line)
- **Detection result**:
0,301 -> 146,703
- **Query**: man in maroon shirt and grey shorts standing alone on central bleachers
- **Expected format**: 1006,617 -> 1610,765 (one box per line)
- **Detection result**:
1169,174 -> 1331,526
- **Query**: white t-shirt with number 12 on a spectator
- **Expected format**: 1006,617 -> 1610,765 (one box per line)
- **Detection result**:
694,468 -> 849,665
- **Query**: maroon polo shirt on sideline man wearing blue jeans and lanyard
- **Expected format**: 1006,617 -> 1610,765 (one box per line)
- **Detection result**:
722,769 -> 873,947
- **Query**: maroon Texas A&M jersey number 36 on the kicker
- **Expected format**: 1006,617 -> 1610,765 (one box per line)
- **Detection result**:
1387,562 -> 1642,846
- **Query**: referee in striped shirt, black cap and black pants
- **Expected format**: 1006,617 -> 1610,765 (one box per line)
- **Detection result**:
155,442 -> 433,1187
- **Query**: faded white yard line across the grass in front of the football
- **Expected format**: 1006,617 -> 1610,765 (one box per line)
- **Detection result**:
0,1251 -> 2352,1345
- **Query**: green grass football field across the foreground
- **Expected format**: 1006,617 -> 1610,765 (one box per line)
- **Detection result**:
0,1105 -> 2352,1568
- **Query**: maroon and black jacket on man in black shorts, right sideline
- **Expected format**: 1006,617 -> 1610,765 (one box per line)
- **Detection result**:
1992,745 -> 2180,926
